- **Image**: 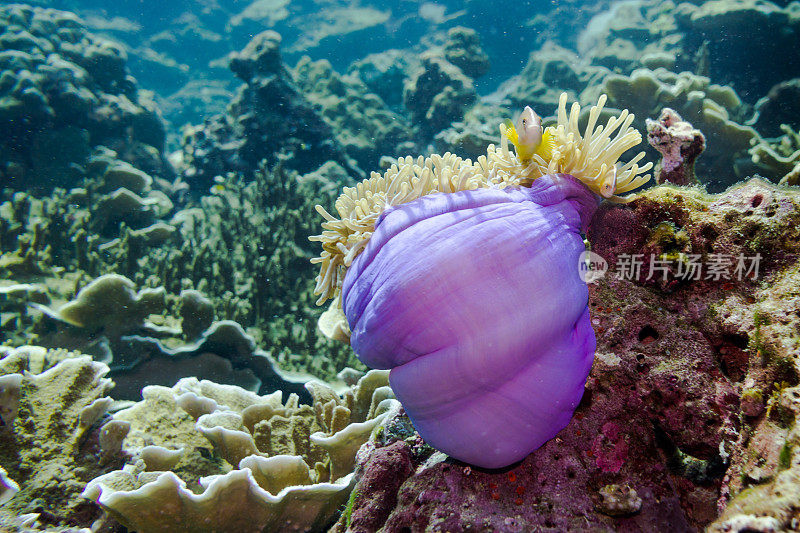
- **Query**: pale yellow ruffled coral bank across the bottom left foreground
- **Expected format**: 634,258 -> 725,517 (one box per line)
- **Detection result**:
0,346 -> 397,532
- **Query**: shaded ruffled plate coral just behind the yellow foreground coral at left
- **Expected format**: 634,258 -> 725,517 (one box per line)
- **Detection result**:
15,274 -> 318,399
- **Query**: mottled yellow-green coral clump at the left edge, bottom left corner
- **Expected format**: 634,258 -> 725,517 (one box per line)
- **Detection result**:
0,347 -> 122,525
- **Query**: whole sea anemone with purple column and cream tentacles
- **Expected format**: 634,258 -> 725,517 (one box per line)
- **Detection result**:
312,95 -> 650,467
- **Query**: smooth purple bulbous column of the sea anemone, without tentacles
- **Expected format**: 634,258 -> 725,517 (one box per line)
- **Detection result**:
342,175 -> 598,468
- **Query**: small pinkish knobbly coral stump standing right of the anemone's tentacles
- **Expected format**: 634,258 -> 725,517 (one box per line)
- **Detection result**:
647,107 -> 706,185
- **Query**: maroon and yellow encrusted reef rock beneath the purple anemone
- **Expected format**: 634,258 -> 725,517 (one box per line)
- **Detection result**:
337,180 -> 800,531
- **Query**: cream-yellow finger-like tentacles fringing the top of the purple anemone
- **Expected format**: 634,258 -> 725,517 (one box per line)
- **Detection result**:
310,93 -> 652,304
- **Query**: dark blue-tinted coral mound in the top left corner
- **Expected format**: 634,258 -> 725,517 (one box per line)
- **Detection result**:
0,4 -> 170,191
